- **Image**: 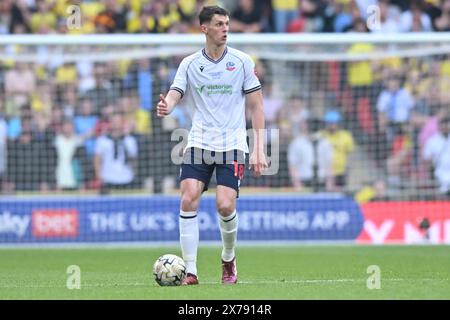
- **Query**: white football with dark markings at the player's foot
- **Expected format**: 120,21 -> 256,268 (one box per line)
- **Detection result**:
153,254 -> 186,286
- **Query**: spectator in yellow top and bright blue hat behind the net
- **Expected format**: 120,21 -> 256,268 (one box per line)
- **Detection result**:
320,110 -> 354,192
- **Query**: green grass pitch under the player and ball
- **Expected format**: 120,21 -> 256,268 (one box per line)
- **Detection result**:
0,245 -> 450,300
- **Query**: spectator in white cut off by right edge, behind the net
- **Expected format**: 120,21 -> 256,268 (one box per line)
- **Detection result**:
423,116 -> 450,196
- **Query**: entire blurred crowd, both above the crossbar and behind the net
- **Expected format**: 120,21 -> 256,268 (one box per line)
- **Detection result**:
0,0 -> 450,200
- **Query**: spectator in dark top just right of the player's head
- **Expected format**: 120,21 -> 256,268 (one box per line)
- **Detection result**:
230,0 -> 262,33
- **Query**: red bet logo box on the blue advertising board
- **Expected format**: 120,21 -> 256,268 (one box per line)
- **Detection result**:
31,209 -> 79,238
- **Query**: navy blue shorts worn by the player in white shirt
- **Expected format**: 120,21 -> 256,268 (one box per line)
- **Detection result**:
180,147 -> 245,197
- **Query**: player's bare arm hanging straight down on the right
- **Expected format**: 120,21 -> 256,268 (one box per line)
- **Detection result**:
246,90 -> 267,177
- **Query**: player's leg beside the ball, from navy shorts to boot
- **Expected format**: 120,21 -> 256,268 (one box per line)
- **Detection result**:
179,149 -> 214,285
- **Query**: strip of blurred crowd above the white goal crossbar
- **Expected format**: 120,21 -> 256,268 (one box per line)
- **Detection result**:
0,0 -> 450,34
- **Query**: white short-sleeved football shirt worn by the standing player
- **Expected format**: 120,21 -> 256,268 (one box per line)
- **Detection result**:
170,47 -> 261,153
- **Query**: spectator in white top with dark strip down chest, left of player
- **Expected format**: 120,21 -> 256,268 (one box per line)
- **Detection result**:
94,113 -> 138,194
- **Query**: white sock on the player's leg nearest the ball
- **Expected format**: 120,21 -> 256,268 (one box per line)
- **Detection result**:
179,210 -> 199,275
